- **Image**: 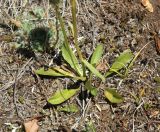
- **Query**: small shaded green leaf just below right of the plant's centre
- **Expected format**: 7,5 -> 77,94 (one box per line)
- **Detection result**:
85,81 -> 98,96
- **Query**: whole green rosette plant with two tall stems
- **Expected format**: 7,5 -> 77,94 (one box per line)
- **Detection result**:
35,0 -> 133,108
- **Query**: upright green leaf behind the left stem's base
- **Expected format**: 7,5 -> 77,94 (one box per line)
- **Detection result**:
62,45 -> 83,76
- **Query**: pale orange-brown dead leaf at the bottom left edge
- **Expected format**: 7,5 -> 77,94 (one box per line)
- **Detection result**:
24,119 -> 39,132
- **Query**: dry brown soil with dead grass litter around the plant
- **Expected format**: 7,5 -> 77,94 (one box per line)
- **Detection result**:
0,0 -> 160,132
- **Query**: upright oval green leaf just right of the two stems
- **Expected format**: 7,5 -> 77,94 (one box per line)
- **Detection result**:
91,45 -> 103,65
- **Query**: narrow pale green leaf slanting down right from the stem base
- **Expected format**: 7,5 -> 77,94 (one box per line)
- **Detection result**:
82,60 -> 105,82
